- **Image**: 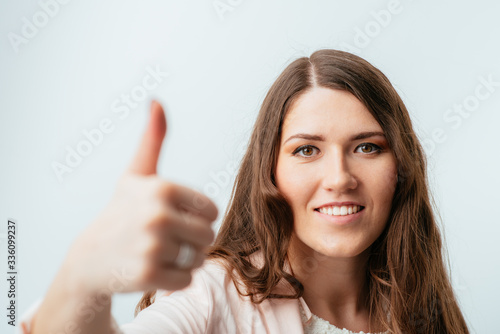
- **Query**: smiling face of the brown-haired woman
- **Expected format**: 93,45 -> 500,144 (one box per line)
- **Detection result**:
275,87 -> 397,257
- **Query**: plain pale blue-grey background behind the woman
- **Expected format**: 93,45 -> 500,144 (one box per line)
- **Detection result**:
0,0 -> 500,333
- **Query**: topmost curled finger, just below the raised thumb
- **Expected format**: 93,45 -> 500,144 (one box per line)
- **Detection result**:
158,182 -> 219,222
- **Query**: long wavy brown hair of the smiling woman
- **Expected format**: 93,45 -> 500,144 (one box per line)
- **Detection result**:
136,50 -> 469,334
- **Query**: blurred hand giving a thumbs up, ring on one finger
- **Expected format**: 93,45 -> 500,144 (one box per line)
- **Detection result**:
64,102 -> 217,293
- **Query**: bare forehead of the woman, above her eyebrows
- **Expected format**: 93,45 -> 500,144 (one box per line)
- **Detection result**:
282,87 -> 382,135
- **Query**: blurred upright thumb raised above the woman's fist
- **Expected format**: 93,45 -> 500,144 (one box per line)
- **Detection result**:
129,101 -> 167,175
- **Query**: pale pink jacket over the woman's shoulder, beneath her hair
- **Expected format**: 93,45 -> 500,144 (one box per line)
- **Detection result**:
145,254 -> 302,333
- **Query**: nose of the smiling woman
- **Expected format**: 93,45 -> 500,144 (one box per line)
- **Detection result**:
323,150 -> 358,193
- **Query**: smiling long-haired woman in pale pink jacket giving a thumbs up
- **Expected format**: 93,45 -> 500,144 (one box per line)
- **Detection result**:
24,50 -> 468,333
